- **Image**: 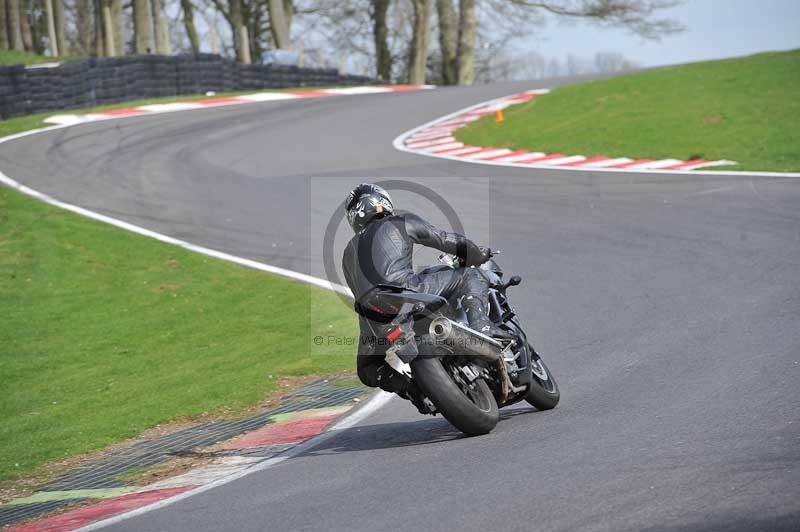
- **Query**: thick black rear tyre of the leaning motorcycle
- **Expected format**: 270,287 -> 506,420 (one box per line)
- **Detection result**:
411,357 -> 500,436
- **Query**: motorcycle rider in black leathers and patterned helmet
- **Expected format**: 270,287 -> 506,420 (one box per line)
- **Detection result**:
342,183 -> 504,413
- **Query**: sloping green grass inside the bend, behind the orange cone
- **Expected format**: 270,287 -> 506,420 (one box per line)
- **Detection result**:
455,50 -> 800,171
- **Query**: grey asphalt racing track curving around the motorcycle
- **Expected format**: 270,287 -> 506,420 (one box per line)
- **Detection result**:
0,80 -> 800,532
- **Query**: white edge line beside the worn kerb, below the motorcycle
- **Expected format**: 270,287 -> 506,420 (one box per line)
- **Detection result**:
76,390 -> 394,532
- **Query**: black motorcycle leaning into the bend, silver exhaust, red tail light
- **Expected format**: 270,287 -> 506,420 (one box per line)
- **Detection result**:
356,251 -> 561,436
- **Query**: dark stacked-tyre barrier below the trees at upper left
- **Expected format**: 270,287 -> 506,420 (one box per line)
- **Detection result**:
0,54 -> 374,119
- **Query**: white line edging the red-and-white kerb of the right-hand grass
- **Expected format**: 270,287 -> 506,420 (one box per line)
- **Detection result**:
392,89 -> 800,178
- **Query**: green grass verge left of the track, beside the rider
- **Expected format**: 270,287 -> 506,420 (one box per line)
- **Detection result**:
0,186 -> 357,479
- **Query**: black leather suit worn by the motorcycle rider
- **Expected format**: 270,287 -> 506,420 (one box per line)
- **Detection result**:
342,213 -> 489,393
